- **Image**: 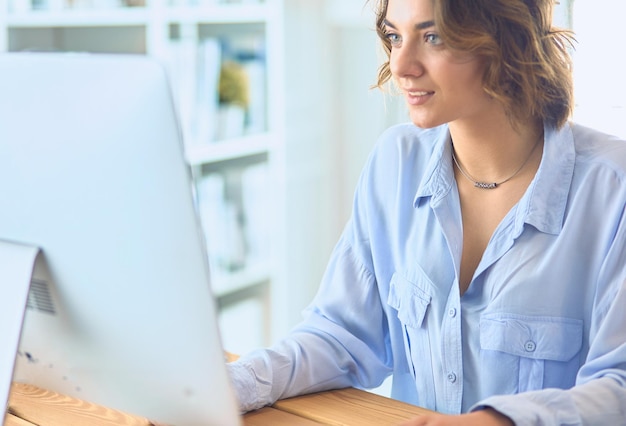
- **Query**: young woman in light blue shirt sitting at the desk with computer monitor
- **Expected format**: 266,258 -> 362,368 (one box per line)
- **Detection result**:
230,0 -> 626,426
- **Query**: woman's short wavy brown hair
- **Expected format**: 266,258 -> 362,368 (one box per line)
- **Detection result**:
375,0 -> 574,128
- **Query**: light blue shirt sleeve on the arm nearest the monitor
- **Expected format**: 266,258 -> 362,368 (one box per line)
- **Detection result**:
228,237 -> 391,412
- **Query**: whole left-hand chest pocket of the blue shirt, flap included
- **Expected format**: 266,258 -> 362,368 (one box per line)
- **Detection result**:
387,273 -> 435,408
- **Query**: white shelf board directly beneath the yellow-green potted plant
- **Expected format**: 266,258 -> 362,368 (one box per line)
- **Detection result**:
185,133 -> 272,166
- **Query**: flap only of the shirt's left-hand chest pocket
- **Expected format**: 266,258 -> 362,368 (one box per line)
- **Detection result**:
387,273 -> 431,328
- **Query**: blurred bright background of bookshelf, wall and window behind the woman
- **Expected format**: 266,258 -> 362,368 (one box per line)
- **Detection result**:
0,0 -> 626,362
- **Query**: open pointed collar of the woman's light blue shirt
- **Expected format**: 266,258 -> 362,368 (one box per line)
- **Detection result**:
414,124 -> 575,235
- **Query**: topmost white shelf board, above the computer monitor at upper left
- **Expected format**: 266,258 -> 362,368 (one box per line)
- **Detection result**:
6,7 -> 149,28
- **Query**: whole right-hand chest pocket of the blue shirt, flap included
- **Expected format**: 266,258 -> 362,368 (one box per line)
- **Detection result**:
480,313 -> 583,392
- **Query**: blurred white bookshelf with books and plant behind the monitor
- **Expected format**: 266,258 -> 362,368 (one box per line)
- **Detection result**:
0,0 -> 284,352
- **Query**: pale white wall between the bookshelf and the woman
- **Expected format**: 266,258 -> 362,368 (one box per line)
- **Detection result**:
274,0 -> 396,338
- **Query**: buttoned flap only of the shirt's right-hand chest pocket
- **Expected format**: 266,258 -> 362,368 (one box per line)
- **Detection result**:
480,313 -> 583,361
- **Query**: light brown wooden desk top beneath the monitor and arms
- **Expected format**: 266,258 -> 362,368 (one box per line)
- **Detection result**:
4,383 -> 429,426
